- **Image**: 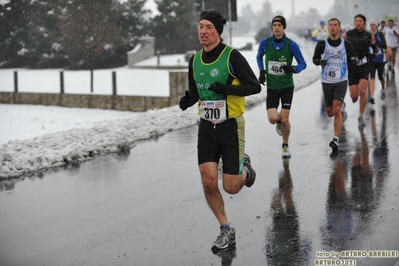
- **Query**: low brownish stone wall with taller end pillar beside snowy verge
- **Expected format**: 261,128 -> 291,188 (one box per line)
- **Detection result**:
0,71 -> 188,112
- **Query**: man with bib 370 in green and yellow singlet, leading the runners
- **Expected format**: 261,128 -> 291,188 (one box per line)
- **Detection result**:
180,10 -> 261,249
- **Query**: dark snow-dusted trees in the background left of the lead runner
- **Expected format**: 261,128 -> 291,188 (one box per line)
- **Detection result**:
0,0 -> 198,69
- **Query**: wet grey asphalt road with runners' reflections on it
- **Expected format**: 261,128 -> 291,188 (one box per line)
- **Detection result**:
0,73 -> 399,266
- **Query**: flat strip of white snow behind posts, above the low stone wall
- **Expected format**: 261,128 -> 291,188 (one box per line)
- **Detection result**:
0,67 -> 169,97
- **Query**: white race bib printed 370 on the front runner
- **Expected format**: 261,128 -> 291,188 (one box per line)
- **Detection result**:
199,100 -> 227,124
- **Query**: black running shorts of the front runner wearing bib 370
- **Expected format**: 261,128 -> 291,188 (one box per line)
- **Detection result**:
197,116 -> 245,175
